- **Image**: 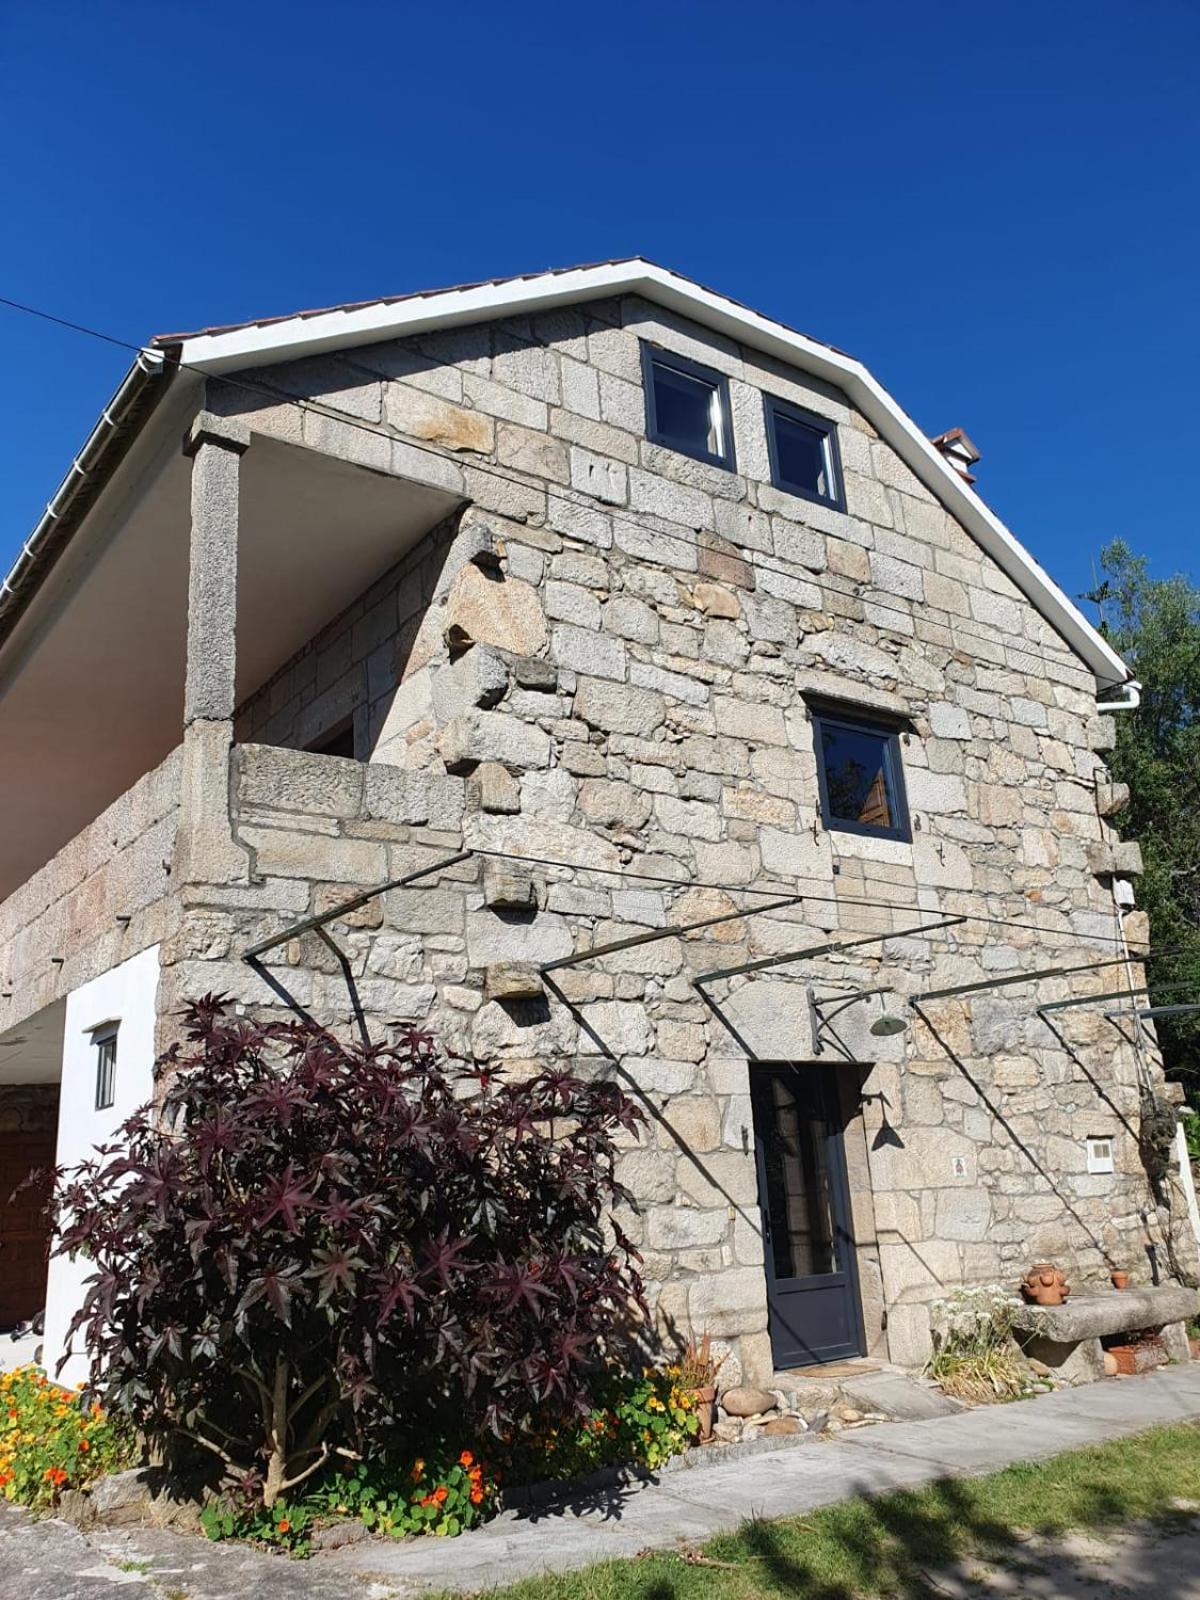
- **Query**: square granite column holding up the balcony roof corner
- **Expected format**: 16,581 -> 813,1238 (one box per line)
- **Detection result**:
184,411 -> 250,726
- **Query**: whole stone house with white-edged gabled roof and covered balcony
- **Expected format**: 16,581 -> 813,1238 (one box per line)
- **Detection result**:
0,259 -> 1194,1378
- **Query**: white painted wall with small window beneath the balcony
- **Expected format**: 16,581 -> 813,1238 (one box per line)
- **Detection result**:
43,944 -> 158,1384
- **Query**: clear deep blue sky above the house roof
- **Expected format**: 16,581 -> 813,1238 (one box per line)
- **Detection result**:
0,0 -> 1200,594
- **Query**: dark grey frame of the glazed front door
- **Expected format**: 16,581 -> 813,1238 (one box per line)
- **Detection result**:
750,1061 -> 867,1370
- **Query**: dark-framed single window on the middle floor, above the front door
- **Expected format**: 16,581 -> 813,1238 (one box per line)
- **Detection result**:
813,707 -> 912,840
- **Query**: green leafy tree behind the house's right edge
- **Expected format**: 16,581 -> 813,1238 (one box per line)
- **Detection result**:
1090,539 -> 1200,1104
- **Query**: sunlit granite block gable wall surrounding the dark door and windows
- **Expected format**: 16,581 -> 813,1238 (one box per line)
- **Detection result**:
72,299 -> 1186,1376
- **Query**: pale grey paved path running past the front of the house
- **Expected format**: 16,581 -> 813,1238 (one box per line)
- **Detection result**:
0,1363 -> 1200,1600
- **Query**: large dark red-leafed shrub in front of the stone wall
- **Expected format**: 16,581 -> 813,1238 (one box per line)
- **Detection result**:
56,997 -> 645,1506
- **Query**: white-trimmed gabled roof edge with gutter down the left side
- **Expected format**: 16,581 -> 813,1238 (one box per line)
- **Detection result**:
0,256 -> 1130,688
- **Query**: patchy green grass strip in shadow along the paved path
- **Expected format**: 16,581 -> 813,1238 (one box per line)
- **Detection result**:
448,1424 -> 1200,1600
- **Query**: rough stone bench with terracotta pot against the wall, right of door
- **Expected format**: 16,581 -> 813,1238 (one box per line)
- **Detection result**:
1014,1283 -> 1200,1384
